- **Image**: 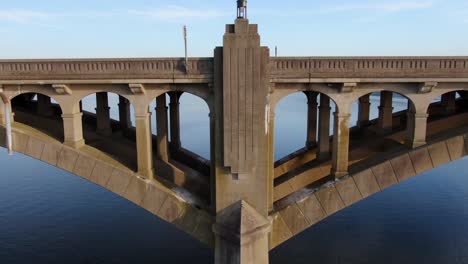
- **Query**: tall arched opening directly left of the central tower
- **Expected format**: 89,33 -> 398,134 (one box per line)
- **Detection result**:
150,91 -> 211,203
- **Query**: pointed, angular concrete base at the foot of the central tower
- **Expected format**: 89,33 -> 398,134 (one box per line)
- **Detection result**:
213,201 -> 271,264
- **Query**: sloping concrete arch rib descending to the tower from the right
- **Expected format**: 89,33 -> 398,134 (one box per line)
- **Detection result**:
270,134 -> 468,249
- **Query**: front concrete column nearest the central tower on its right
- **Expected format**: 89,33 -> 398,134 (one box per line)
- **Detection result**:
332,112 -> 351,178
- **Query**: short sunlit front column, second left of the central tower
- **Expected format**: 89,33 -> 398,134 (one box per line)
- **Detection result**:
62,107 -> 85,148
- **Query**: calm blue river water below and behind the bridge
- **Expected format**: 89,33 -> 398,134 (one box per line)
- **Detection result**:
0,94 -> 468,264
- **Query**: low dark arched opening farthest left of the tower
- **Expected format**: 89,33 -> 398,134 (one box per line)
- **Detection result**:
10,92 -> 64,142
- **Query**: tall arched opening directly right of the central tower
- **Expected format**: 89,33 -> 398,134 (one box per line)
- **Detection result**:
271,91 -> 339,202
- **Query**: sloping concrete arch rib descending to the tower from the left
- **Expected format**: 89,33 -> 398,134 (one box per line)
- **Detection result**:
0,123 -> 214,247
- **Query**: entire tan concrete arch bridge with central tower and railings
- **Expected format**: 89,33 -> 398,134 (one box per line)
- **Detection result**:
0,14 -> 468,264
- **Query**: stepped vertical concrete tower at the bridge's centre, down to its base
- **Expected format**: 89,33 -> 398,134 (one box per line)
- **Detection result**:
214,4 -> 273,264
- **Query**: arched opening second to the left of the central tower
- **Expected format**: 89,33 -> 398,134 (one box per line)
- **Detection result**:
80,92 -> 137,171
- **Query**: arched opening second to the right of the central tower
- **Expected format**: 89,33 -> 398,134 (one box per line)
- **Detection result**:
348,90 -> 414,172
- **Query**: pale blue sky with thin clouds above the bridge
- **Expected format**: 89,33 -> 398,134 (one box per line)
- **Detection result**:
0,0 -> 468,58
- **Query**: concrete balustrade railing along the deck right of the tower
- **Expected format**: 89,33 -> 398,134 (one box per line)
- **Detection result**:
270,57 -> 468,79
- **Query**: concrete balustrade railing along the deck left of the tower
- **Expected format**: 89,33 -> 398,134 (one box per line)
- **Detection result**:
0,58 -> 213,80
